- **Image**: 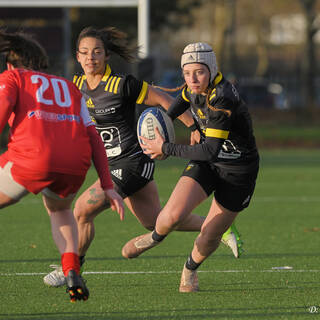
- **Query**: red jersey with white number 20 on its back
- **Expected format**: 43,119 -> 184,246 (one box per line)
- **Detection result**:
0,69 -> 93,175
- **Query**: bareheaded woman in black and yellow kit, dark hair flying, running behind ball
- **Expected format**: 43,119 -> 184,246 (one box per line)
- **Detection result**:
44,27 -> 241,287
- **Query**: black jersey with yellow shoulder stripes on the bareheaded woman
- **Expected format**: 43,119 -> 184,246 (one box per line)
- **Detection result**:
73,65 -> 148,163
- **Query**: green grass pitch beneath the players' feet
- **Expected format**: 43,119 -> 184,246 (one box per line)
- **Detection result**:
0,150 -> 320,320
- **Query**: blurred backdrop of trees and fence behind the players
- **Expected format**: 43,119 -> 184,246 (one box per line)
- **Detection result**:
0,0 -> 320,148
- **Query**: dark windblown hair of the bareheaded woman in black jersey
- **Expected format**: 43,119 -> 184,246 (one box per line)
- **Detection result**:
76,26 -> 138,62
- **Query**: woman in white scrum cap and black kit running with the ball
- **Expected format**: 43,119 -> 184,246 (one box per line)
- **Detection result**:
122,42 -> 259,292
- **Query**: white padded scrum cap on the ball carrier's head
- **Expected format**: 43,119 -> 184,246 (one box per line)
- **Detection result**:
181,42 -> 218,82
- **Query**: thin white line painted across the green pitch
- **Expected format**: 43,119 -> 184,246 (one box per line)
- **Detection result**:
0,269 -> 320,277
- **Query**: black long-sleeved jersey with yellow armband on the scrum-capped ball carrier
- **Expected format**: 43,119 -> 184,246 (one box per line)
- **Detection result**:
162,72 -> 259,167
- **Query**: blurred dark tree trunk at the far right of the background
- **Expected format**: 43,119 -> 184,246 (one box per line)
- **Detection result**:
300,0 -> 320,108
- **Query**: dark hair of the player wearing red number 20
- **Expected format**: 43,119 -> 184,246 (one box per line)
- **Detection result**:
0,30 -> 49,71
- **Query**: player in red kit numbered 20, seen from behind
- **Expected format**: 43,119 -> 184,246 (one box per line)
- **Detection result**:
0,31 -> 124,302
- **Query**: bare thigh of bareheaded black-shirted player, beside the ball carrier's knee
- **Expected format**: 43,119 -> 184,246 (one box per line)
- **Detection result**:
124,181 -> 161,229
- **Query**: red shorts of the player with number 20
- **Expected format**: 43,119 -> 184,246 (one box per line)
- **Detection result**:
0,154 -> 85,198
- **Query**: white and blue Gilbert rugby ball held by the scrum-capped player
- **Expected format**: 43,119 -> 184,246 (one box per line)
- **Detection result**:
137,107 -> 175,160
